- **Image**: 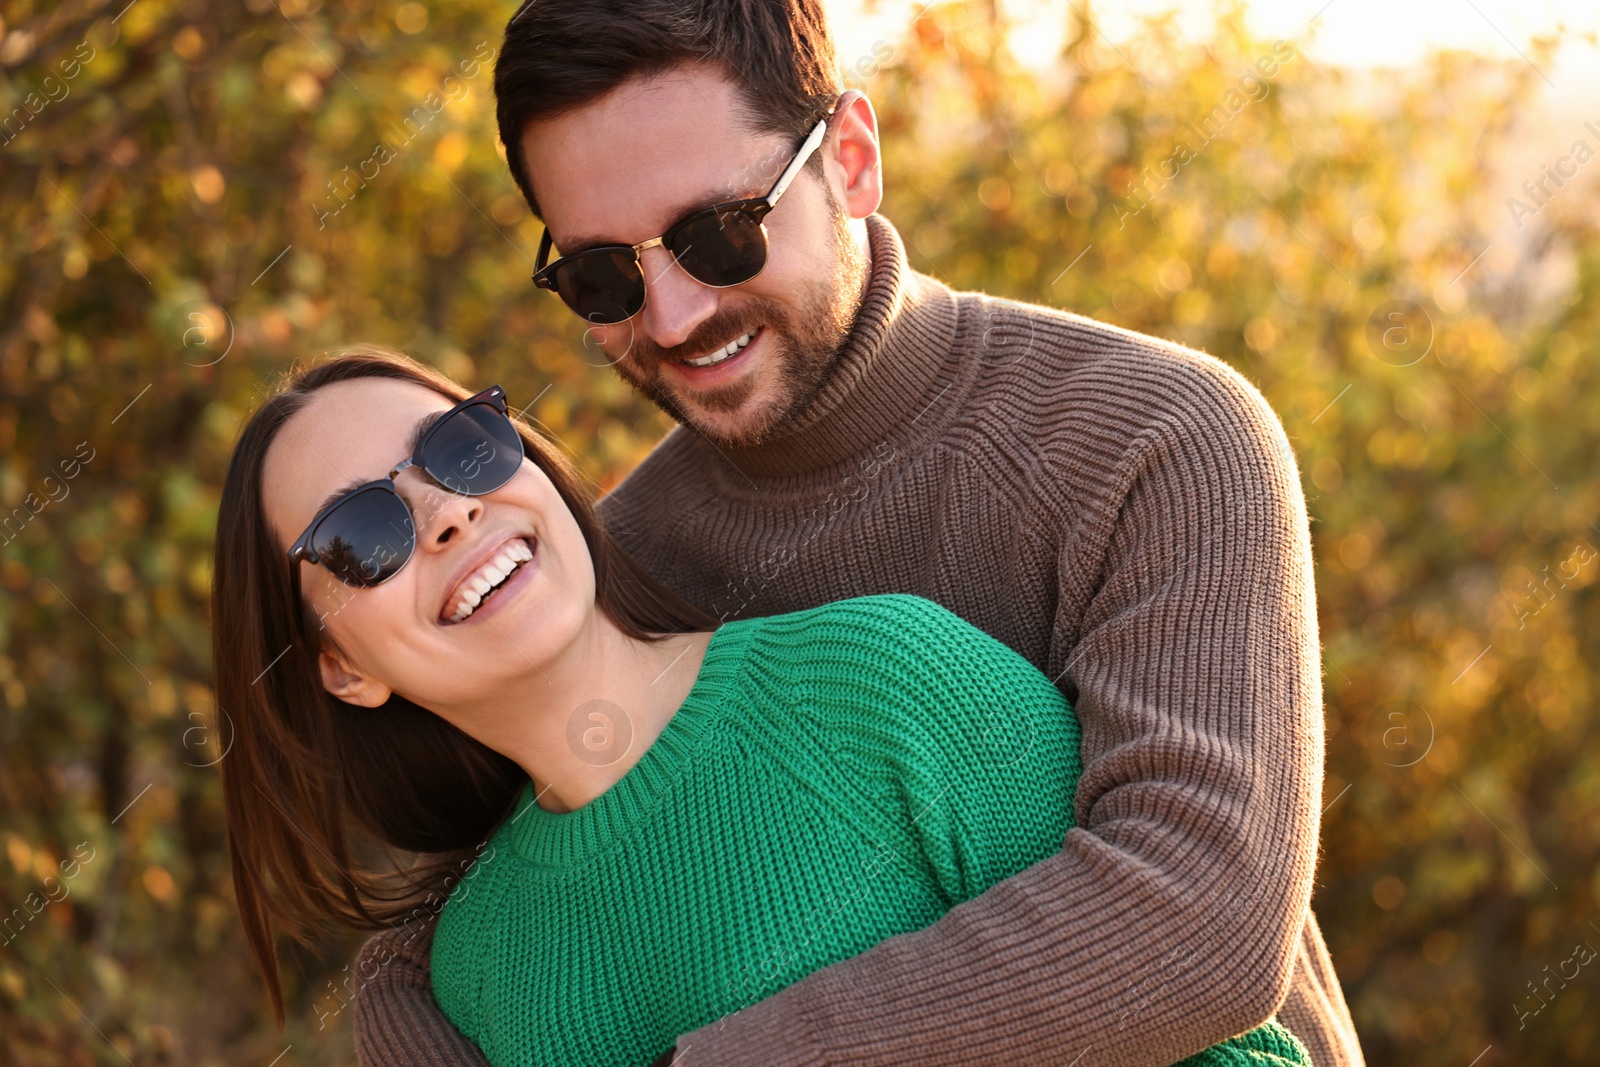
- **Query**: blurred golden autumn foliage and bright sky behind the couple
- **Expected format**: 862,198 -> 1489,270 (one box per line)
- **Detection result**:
0,0 -> 1600,1067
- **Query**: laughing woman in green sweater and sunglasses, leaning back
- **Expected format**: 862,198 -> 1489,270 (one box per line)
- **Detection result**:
213,349 -> 1307,1065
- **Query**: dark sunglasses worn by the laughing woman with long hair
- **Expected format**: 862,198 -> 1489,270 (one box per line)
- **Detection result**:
290,386 -> 523,608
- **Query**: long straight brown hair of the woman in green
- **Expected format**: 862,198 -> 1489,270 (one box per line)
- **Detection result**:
211,346 -> 717,1029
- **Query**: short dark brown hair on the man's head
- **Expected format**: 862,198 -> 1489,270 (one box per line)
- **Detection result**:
494,0 -> 843,219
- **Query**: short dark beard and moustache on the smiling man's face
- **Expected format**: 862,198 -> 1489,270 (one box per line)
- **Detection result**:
604,198 -> 867,446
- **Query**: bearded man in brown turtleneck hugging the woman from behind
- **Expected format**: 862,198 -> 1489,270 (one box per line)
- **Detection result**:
357,0 -> 1362,1067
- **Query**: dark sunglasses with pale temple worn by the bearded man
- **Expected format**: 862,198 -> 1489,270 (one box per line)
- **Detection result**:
533,109 -> 834,326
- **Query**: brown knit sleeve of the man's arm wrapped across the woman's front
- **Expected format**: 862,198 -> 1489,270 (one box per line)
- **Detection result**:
678,358 -> 1323,1067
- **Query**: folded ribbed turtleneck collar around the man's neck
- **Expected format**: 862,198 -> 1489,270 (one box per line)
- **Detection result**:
702,214 -> 963,477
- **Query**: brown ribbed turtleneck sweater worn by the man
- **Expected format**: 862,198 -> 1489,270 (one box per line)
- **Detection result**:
355,216 -> 1362,1067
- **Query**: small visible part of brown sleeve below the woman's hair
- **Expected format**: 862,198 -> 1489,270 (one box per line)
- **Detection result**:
355,915 -> 488,1067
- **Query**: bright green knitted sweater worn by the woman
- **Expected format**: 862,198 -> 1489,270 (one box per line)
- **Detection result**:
432,595 -> 1310,1067
